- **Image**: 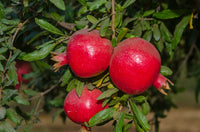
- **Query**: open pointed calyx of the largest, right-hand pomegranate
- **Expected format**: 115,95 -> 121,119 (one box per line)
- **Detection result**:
153,74 -> 174,95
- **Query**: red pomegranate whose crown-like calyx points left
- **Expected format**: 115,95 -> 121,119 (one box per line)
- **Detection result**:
52,29 -> 113,78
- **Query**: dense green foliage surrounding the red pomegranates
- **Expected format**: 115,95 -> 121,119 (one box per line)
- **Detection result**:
0,0 -> 200,132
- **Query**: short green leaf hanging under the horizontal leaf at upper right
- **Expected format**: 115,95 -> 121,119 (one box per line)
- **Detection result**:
160,22 -> 172,42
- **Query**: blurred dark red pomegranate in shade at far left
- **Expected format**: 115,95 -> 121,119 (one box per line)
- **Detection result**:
15,60 -> 33,89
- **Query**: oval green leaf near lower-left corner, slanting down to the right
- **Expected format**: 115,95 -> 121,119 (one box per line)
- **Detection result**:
6,109 -> 20,125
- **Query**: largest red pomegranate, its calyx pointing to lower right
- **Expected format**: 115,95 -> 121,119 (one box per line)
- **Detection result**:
109,38 -> 172,95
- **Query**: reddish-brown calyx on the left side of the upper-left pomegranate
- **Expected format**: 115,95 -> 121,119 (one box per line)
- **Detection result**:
51,52 -> 68,72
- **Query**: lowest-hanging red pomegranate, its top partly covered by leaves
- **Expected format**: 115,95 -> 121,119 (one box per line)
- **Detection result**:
64,87 -> 108,124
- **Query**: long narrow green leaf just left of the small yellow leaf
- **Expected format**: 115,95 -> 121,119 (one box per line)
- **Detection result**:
172,15 -> 191,49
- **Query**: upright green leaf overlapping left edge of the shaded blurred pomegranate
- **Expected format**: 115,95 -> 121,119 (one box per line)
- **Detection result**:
7,62 -> 19,85
